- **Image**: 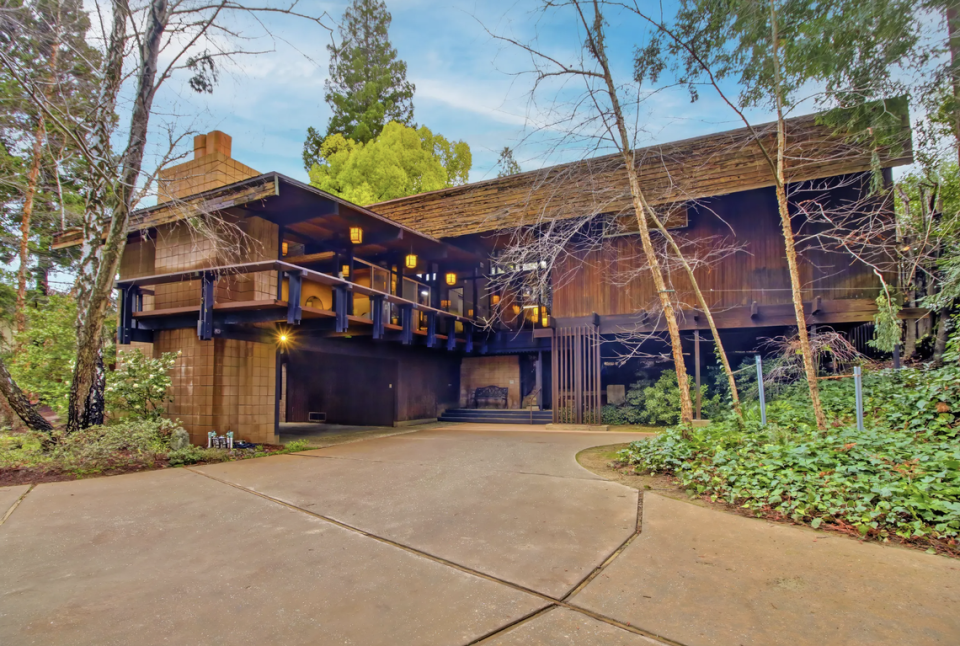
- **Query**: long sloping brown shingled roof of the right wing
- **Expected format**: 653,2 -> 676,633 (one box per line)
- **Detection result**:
370,115 -> 913,238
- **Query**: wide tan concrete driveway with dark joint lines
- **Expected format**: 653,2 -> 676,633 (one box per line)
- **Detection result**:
0,425 -> 960,646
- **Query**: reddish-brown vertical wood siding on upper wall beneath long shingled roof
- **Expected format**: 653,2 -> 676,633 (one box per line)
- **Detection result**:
552,188 -> 880,318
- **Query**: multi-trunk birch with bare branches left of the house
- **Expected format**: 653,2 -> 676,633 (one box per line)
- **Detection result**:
0,0 -> 328,432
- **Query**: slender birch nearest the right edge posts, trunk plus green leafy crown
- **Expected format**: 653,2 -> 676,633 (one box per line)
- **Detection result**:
625,0 -> 916,430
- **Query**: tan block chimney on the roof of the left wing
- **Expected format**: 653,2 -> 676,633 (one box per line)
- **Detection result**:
157,130 -> 260,204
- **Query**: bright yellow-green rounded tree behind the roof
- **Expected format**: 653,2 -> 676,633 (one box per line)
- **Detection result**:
310,121 -> 472,205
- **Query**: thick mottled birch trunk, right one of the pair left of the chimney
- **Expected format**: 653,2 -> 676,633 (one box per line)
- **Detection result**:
67,0 -> 169,432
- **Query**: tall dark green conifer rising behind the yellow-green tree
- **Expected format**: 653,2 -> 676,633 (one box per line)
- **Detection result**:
303,0 -> 416,170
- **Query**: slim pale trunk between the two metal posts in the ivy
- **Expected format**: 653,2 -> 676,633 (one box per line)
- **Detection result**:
770,2 -> 827,431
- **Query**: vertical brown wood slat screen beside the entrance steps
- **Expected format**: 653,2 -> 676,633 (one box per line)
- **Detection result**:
551,325 -> 601,424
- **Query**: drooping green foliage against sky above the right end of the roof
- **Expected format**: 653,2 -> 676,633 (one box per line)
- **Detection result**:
664,0 -> 917,108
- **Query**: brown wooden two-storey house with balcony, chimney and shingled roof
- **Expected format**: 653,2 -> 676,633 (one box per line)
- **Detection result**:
55,112 -> 912,442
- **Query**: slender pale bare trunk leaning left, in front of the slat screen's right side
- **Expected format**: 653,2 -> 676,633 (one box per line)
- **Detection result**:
578,3 -> 693,424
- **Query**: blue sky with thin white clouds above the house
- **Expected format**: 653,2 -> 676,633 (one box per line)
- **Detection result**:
144,0 -> 796,187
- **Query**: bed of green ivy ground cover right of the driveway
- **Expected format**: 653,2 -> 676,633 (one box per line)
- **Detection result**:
620,365 -> 960,542
